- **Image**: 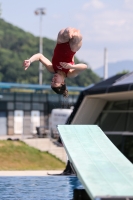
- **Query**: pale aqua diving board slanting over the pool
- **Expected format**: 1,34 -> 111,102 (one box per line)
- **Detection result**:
58,125 -> 133,200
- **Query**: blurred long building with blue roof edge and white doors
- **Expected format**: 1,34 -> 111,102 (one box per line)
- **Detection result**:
0,83 -> 83,135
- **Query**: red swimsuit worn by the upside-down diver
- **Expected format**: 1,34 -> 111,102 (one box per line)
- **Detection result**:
52,42 -> 76,75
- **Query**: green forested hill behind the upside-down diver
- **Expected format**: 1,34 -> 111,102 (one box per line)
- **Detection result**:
0,19 -> 100,86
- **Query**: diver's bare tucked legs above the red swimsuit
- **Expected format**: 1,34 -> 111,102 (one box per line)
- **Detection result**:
57,27 -> 82,52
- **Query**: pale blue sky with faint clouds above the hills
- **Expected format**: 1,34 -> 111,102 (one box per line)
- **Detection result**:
0,0 -> 133,70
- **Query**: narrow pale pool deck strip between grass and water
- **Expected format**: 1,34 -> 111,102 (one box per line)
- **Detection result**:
0,170 -> 62,177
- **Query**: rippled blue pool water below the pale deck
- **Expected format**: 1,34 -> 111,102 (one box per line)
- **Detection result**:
0,176 -> 83,200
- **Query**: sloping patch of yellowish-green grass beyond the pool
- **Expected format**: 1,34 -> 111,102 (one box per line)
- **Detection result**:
0,140 -> 65,170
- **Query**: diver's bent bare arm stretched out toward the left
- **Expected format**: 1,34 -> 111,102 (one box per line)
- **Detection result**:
23,53 -> 54,72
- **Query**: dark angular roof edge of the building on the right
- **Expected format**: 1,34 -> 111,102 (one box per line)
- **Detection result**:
67,72 -> 133,124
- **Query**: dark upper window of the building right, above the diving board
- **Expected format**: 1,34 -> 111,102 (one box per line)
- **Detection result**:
96,100 -> 133,132
